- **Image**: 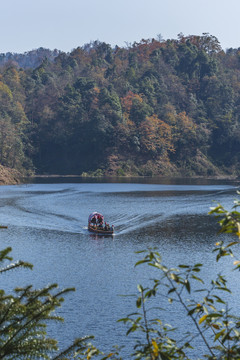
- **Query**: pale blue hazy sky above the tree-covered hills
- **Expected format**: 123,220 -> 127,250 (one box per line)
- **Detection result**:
0,0 -> 240,53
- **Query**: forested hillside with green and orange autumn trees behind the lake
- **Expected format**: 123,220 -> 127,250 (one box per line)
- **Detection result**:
0,33 -> 240,176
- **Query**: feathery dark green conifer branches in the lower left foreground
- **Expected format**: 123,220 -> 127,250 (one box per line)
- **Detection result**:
0,247 -> 94,360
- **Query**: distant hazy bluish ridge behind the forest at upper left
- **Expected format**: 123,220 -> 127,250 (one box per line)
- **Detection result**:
0,47 -> 62,69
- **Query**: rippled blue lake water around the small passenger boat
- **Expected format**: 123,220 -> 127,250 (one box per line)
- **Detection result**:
0,178 -> 239,359
